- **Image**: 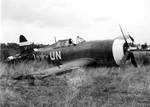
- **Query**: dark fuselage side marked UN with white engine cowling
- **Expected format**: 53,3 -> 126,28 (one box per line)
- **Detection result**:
34,40 -> 124,66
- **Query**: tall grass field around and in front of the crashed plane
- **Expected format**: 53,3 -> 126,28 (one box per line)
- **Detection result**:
0,59 -> 150,107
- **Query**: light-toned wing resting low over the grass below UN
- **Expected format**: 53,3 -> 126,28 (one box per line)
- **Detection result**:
29,58 -> 95,78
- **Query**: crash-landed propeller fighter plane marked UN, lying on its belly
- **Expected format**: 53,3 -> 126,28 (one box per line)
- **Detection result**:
10,27 -> 137,80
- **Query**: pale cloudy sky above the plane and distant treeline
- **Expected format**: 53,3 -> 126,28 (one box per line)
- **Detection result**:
0,0 -> 150,44
